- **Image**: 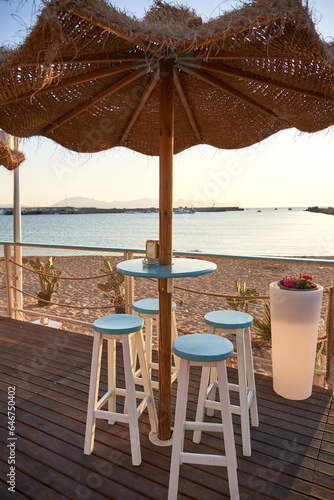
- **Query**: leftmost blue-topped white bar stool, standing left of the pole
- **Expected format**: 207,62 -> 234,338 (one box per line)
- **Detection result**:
84,314 -> 157,465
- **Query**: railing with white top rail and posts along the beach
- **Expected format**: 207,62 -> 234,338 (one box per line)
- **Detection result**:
0,242 -> 334,387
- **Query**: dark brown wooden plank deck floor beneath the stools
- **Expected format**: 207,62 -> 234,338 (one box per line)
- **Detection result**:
0,318 -> 334,500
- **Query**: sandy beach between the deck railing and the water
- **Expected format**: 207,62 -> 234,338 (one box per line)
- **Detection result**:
0,254 -> 334,378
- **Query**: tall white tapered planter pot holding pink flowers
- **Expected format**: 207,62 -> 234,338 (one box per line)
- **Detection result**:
270,282 -> 323,400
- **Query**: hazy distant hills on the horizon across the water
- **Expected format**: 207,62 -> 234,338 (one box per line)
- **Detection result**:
51,196 -> 240,208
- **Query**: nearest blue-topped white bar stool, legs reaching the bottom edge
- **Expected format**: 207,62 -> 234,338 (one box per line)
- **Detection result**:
168,333 -> 239,500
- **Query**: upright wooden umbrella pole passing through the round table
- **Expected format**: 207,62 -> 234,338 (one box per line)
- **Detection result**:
158,60 -> 174,441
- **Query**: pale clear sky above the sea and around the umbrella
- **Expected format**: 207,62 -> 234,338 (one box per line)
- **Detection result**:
0,0 -> 334,208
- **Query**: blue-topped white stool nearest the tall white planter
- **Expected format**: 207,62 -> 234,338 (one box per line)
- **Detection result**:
193,311 -> 259,457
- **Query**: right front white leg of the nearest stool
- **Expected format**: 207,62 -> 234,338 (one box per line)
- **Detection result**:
217,361 -> 239,500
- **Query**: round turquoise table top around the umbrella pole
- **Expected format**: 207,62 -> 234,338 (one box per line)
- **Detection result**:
116,259 -> 217,278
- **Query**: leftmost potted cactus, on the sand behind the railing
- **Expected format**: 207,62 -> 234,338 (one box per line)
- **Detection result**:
22,257 -> 61,307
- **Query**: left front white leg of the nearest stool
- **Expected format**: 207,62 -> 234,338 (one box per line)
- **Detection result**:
168,359 -> 189,500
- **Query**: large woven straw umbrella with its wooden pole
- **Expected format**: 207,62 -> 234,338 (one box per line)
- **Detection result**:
0,0 -> 334,440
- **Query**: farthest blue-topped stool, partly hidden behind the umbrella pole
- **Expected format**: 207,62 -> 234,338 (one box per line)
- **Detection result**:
132,299 -> 179,389
